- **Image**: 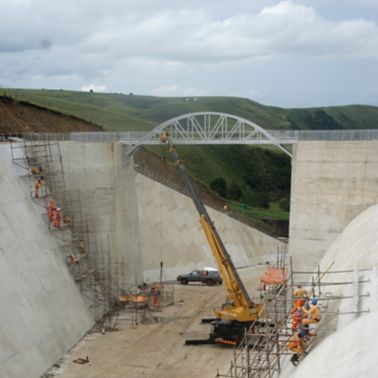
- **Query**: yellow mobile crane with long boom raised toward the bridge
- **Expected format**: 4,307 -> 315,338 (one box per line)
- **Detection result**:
160,131 -> 263,345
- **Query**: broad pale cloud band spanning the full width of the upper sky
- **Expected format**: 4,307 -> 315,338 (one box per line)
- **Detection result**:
0,0 -> 378,63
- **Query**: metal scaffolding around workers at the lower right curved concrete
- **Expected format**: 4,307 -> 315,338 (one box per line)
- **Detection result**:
216,252 -> 370,378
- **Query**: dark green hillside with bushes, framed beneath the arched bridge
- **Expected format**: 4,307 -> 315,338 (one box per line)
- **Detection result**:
149,145 -> 291,211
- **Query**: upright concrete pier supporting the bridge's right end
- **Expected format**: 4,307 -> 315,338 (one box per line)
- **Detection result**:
289,141 -> 378,269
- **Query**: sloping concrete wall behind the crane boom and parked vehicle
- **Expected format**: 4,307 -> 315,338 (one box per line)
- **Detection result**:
136,174 -> 282,281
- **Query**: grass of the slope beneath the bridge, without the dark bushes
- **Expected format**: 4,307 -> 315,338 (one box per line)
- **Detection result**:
149,145 -> 290,220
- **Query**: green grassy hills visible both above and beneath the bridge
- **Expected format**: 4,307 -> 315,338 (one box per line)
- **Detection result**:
1,89 -> 378,224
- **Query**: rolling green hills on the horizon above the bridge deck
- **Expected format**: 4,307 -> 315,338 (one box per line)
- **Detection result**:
2,89 -> 378,131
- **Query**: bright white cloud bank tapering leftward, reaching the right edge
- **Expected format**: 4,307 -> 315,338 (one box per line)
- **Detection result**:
79,1 -> 378,62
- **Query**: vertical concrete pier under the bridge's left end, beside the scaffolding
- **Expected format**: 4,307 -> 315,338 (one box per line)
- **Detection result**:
60,142 -> 143,285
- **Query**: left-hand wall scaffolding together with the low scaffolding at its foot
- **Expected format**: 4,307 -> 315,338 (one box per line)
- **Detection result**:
11,133 -> 173,323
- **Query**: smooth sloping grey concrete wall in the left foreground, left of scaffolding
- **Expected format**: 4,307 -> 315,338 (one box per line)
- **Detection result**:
0,144 -> 93,378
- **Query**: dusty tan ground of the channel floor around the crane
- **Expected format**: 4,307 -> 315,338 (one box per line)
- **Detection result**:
51,266 -> 265,378
